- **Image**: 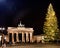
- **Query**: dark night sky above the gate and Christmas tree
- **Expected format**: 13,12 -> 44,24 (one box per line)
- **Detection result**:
0,0 -> 60,35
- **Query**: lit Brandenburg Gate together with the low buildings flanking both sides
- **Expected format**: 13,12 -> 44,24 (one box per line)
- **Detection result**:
2,22 -> 44,44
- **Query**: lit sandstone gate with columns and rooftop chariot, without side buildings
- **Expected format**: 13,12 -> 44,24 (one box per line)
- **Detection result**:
6,23 -> 34,43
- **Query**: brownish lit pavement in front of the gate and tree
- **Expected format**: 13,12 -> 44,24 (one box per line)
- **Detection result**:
0,44 -> 60,48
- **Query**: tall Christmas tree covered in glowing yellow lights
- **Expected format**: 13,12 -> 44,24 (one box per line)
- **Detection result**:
43,3 -> 59,41
